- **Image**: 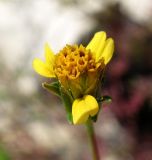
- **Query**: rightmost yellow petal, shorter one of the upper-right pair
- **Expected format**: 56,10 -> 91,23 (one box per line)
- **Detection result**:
99,38 -> 114,65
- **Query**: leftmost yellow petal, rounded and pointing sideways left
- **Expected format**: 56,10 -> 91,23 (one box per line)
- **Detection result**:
33,58 -> 55,77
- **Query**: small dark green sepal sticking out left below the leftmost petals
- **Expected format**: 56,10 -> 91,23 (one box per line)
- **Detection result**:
42,81 -> 61,97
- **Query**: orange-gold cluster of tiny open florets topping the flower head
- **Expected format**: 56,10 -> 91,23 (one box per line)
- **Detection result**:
54,45 -> 104,79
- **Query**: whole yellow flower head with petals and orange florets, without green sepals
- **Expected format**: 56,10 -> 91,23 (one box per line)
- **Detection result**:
33,31 -> 114,124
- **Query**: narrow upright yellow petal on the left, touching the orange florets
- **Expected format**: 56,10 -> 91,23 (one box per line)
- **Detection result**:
45,43 -> 55,65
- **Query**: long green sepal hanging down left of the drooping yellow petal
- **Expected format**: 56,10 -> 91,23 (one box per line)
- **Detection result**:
60,88 -> 73,124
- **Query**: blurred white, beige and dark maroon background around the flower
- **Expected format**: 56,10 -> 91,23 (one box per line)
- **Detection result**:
0,0 -> 152,160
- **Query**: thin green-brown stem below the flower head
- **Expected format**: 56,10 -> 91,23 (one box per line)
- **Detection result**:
86,120 -> 100,160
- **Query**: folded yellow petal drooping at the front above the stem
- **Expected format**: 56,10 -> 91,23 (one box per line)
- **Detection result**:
72,95 -> 99,124
